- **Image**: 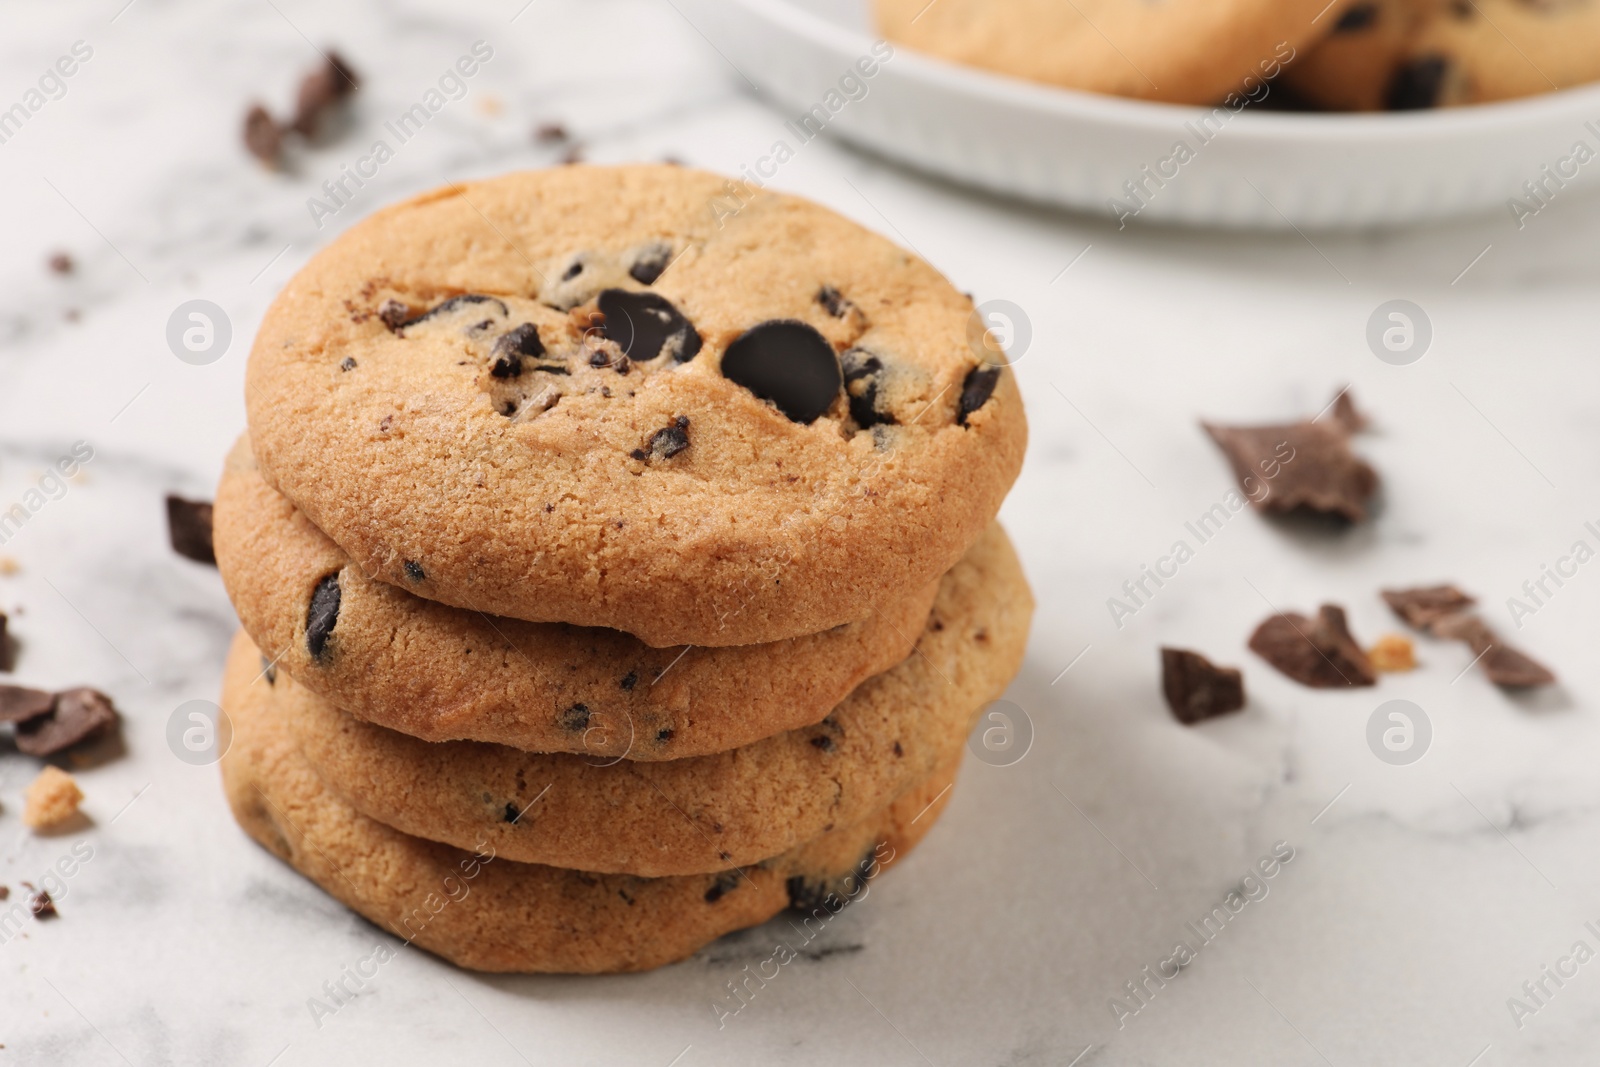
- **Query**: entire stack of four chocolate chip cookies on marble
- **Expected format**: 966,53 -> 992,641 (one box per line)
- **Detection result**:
216,166 -> 1032,973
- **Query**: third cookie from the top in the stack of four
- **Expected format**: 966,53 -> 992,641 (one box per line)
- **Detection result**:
249,526 -> 1032,877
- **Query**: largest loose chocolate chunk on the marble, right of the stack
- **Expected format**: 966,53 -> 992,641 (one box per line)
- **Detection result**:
1200,421 -> 1378,523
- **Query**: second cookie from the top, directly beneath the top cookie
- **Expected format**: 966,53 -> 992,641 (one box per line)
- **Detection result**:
214,440 -> 934,761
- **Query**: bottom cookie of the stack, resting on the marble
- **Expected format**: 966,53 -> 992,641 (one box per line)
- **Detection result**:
222,633 -> 960,974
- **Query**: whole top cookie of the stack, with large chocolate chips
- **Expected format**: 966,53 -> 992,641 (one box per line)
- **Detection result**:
246,166 -> 1027,646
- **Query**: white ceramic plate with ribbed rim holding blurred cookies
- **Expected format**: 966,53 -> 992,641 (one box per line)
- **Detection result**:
674,0 -> 1600,229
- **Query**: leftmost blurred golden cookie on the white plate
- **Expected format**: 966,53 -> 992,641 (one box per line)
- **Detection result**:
877,0 -> 1344,104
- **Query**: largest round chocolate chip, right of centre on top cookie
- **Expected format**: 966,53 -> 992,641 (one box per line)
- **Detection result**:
722,318 -> 843,422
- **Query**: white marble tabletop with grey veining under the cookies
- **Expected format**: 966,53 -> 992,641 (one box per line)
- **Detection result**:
0,0 -> 1600,1067
